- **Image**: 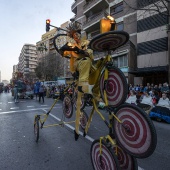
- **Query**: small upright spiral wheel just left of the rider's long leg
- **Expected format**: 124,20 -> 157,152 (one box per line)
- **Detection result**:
63,95 -> 73,118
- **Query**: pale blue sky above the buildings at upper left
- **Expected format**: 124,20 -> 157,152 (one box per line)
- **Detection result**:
0,0 -> 74,81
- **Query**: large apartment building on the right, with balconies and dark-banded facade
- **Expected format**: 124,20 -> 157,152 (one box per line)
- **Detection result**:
71,0 -> 168,84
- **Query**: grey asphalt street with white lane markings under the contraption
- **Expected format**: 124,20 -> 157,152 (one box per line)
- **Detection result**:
0,93 -> 170,170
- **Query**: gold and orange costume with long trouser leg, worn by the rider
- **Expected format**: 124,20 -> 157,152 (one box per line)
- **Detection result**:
63,36 -> 93,140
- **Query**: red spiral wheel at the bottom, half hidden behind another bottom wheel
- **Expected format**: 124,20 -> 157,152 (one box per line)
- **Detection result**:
113,145 -> 138,170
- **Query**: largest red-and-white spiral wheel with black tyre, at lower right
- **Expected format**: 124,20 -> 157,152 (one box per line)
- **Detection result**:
113,104 -> 157,158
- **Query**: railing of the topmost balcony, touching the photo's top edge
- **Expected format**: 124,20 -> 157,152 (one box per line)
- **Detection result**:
83,0 -> 109,13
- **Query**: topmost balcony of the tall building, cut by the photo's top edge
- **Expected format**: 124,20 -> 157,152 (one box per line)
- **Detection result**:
83,0 -> 109,16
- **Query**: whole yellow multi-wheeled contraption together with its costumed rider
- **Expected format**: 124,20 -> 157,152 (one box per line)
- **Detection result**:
34,16 -> 157,170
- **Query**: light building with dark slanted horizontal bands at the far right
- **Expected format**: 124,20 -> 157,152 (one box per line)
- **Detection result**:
134,0 -> 170,84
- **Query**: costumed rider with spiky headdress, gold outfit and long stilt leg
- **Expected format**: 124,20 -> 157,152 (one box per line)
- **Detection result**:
60,22 -> 93,140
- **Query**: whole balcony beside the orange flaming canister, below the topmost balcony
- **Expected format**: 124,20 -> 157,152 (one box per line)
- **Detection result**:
83,11 -> 107,32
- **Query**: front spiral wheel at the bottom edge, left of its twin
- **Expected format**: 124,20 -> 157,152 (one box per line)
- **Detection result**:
90,140 -> 120,170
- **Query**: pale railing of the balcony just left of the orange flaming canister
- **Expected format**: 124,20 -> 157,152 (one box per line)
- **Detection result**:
83,11 -> 107,30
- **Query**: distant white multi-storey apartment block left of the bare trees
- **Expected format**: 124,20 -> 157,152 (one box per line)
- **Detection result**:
18,44 -> 38,79
